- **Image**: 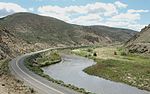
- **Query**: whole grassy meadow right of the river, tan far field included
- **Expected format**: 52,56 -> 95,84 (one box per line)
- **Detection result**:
73,47 -> 150,91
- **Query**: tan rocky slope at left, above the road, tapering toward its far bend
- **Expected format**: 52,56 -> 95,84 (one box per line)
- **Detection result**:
0,27 -> 52,60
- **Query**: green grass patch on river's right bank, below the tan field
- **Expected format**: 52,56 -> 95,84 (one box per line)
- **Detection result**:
84,55 -> 150,91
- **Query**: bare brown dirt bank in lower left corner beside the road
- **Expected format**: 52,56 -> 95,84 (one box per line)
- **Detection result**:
0,59 -> 36,94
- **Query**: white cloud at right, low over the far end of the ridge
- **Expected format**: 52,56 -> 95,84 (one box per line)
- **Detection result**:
105,9 -> 149,31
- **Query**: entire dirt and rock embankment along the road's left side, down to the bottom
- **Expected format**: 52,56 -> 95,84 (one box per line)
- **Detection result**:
0,27 -> 48,94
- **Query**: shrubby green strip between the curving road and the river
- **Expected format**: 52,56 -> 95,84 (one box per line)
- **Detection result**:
25,51 -> 94,94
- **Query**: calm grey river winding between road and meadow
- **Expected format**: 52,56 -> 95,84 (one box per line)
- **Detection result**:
43,55 -> 150,94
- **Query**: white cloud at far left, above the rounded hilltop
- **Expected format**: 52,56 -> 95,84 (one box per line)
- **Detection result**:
0,2 -> 27,17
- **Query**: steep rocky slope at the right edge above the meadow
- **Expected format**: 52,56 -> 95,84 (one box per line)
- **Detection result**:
125,25 -> 150,54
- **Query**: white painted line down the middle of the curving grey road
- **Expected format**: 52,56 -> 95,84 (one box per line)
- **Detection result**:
16,55 -> 64,94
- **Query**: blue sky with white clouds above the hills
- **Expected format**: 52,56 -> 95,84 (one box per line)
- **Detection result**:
0,0 -> 150,31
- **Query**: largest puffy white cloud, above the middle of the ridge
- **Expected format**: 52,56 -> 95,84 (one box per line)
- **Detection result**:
38,2 -> 118,25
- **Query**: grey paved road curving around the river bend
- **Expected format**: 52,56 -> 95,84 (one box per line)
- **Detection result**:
9,48 -> 79,94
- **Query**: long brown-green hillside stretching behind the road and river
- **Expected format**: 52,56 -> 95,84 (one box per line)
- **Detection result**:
0,13 -> 136,58
